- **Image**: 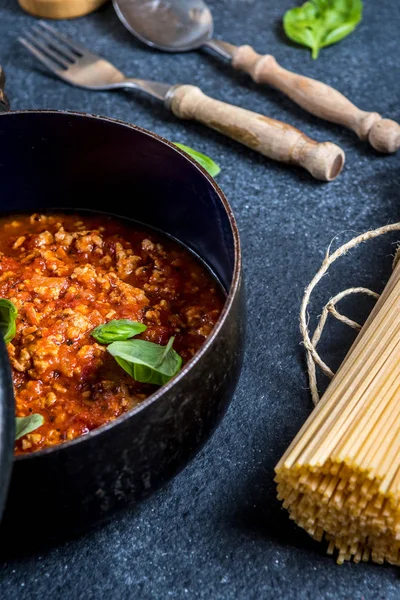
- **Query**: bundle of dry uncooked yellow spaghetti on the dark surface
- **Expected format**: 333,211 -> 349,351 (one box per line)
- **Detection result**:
276,224 -> 400,565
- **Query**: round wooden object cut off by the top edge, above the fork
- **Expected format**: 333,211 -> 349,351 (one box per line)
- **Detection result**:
18,0 -> 107,19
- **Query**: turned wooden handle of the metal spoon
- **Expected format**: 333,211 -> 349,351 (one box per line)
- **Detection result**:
232,46 -> 400,153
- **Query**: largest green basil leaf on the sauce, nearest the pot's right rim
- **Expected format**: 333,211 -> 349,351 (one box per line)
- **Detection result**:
107,337 -> 182,385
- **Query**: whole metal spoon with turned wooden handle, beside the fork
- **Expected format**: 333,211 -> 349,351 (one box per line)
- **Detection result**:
113,0 -> 400,152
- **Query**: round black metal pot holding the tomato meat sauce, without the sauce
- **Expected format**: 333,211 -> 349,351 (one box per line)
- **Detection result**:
0,69 -> 244,553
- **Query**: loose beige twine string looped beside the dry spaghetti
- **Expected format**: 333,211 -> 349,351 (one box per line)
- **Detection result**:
300,223 -> 400,405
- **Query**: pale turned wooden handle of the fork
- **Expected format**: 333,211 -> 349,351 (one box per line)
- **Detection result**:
168,85 -> 344,181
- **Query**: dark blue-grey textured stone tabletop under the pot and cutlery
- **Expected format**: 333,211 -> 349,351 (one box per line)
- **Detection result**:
0,0 -> 400,600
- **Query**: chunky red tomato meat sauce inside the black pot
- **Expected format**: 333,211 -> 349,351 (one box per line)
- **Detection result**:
0,213 -> 225,454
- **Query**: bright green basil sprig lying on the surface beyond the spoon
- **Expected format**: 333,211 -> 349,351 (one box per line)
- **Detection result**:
283,0 -> 363,58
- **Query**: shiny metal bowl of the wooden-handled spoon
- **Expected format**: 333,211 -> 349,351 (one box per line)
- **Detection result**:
113,0 -> 214,52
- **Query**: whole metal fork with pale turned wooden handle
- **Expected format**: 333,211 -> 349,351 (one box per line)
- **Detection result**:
18,21 -> 344,181
